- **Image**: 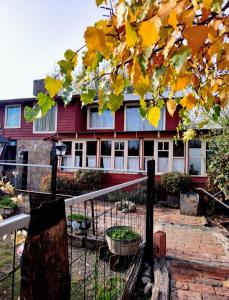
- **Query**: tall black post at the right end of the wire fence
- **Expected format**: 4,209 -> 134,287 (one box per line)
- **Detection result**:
145,160 -> 155,270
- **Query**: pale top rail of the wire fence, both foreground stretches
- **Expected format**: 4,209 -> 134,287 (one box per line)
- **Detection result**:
0,177 -> 147,237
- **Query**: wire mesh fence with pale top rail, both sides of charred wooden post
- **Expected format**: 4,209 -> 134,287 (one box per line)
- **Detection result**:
0,177 -> 150,300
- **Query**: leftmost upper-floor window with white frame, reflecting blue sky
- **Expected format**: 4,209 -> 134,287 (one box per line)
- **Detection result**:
5,105 -> 21,128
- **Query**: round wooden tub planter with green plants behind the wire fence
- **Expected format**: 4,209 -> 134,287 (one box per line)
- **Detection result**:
106,226 -> 142,256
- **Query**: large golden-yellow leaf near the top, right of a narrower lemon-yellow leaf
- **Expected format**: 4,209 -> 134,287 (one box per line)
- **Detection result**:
138,19 -> 160,47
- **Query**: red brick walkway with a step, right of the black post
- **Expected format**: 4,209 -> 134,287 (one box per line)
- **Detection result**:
155,209 -> 229,300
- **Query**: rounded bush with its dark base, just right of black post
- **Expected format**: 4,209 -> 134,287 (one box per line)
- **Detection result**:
161,172 -> 192,208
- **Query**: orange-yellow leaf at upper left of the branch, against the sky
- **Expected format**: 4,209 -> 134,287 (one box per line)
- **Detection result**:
84,27 -> 106,52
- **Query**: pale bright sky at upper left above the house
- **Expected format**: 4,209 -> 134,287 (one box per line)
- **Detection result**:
0,0 -> 104,100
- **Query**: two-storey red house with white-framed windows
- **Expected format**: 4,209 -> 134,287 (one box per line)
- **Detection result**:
0,94 -> 207,183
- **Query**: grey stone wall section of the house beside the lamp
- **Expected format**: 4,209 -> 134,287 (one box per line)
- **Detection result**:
17,140 -> 52,191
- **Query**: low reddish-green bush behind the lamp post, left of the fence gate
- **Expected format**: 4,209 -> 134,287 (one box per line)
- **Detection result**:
40,170 -> 104,196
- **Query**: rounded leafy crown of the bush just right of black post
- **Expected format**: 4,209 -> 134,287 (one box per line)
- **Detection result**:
161,172 -> 192,194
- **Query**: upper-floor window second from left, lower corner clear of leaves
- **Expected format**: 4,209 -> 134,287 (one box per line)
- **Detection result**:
34,106 -> 56,133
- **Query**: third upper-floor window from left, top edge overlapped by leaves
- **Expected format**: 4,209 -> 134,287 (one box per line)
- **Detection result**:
88,107 -> 114,129
